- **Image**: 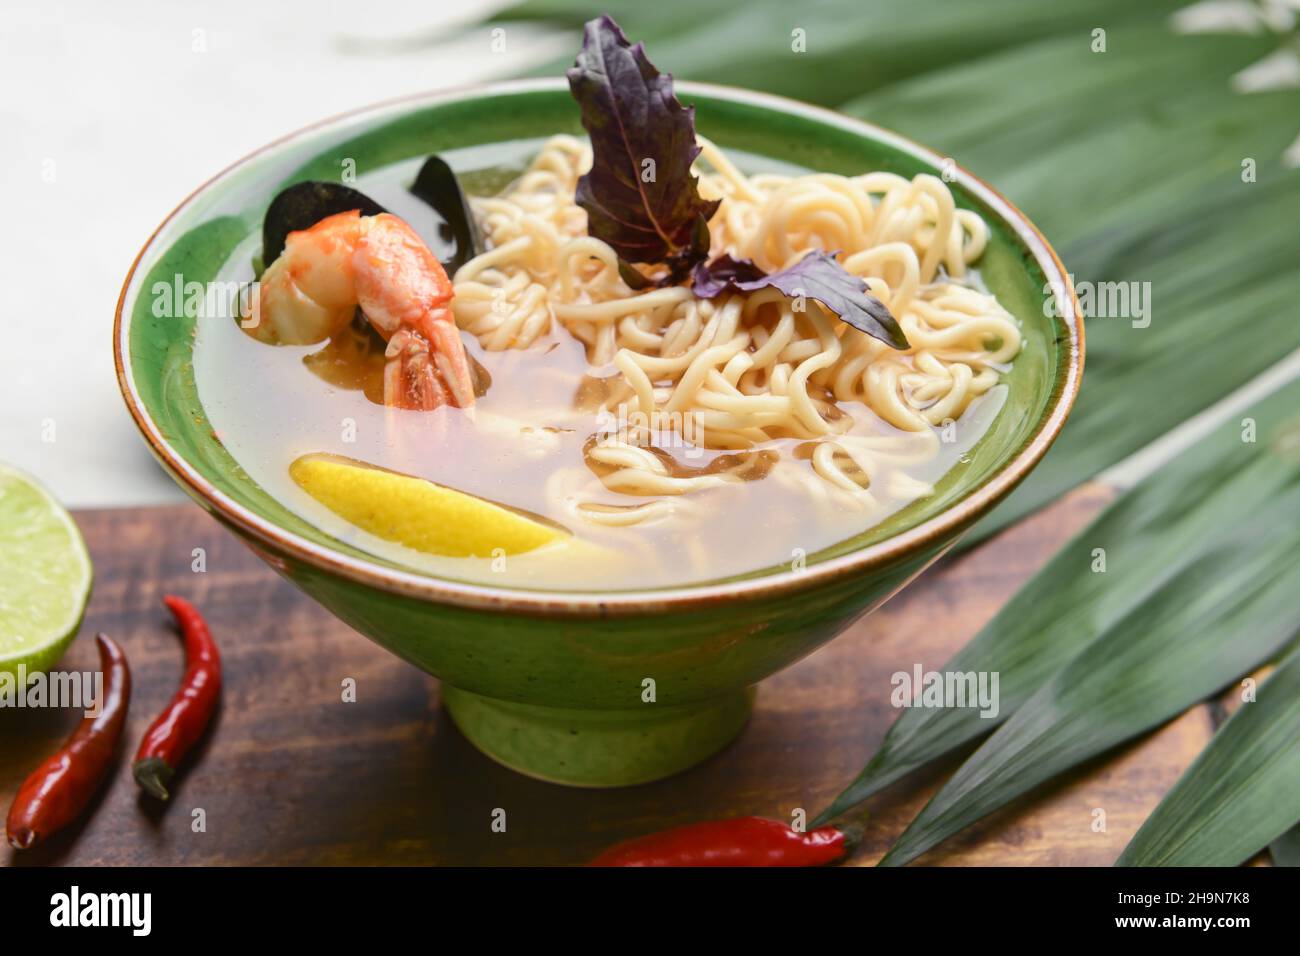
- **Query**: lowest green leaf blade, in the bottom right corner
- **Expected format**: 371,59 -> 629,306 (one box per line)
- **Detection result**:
1115,652 -> 1300,866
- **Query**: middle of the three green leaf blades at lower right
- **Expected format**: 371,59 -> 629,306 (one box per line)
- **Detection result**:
881,381 -> 1300,865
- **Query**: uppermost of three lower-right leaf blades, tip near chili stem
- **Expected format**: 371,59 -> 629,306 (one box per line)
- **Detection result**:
816,382 -> 1300,825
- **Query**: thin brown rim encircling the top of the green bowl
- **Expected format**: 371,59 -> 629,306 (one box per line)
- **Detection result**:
113,78 -> 1084,618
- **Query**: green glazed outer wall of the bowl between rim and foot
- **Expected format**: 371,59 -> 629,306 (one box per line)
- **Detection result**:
283,538 -> 937,710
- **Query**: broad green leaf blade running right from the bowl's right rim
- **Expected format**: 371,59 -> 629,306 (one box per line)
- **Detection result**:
977,170 -> 1300,548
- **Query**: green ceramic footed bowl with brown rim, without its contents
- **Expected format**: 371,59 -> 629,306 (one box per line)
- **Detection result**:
113,79 -> 1083,786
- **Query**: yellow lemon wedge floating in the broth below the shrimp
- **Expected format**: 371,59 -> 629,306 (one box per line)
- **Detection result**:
289,454 -> 568,558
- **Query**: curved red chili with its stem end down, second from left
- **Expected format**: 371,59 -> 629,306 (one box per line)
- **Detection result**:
131,594 -> 221,800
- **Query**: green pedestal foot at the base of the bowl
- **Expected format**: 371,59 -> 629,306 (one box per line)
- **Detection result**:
442,684 -> 754,787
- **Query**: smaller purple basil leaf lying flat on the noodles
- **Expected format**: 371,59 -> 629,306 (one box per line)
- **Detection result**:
692,250 -> 909,349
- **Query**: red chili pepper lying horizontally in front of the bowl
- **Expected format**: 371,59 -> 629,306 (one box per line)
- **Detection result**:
589,817 -> 861,866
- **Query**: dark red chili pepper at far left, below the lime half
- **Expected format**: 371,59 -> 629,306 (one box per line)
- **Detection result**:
5,633 -> 131,849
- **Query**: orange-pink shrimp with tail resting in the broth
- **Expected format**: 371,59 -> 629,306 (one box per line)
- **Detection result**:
244,209 -> 475,410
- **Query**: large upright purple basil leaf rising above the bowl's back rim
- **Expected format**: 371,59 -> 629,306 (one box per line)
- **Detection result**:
567,17 -> 718,267
